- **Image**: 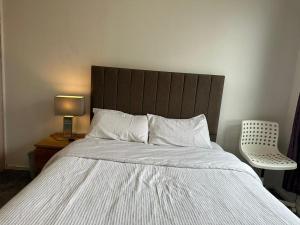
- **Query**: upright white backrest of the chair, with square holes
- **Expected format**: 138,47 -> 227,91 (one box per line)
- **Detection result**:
240,120 -> 279,150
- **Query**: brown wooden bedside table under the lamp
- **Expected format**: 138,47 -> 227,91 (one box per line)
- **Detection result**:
33,133 -> 85,175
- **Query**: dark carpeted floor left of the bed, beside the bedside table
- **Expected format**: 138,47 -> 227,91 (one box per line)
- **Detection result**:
0,170 -> 31,208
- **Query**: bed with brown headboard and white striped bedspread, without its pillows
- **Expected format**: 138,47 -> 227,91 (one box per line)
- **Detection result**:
0,66 -> 300,225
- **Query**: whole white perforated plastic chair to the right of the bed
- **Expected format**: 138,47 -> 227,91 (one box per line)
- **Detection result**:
240,120 -> 297,174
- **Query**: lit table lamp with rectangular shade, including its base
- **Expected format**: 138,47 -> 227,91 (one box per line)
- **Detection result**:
54,95 -> 85,138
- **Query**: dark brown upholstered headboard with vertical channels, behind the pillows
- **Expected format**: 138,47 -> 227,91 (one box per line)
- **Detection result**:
90,66 -> 224,141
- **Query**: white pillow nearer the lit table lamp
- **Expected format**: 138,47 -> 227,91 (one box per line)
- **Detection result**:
87,109 -> 148,143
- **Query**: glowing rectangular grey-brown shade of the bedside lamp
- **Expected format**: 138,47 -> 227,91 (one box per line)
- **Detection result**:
54,95 -> 85,116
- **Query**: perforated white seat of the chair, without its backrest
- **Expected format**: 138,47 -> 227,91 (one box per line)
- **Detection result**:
243,152 -> 297,170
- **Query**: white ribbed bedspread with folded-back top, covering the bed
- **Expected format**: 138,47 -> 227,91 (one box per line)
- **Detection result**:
0,138 -> 300,225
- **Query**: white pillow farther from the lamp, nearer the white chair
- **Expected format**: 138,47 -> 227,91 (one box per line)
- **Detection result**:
147,114 -> 212,148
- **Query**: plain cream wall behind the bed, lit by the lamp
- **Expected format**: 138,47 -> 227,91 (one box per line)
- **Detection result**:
4,0 -> 300,167
